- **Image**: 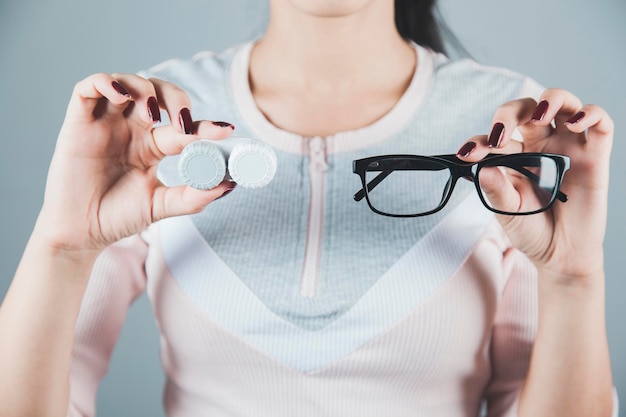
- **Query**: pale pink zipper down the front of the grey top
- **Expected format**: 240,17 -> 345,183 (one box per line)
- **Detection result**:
300,136 -> 328,298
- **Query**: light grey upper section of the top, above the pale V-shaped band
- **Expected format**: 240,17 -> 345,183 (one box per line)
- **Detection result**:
154,44 -> 537,330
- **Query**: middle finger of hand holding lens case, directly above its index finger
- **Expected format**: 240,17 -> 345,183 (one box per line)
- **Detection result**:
150,78 -> 194,135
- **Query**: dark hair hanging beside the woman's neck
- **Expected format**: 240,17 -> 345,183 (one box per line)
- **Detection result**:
395,0 -> 468,55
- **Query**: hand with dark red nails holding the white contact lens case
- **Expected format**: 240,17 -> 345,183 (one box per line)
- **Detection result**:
35,74 -> 234,253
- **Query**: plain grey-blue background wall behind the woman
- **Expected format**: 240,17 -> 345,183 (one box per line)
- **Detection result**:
0,0 -> 626,416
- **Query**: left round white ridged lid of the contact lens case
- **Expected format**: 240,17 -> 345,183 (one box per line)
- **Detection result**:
178,139 -> 226,190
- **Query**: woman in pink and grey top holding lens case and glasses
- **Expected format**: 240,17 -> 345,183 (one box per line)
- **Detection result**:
0,0 -> 616,416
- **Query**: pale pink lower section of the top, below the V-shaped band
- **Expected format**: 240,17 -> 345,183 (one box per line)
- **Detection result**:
101,218 -> 536,417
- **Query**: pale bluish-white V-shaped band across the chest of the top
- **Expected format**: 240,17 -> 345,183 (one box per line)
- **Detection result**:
159,192 -> 491,372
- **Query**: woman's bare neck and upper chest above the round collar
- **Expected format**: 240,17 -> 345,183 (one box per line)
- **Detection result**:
250,0 -> 416,136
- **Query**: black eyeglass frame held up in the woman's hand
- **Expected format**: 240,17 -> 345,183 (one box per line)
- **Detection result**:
352,152 -> 570,217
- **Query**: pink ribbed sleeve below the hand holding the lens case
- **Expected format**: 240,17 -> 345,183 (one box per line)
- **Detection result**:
68,235 -> 147,417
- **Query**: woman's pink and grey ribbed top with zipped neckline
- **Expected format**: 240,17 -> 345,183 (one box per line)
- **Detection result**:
69,44 -> 617,417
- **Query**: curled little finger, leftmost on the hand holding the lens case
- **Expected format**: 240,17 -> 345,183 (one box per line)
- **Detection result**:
66,73 -> 133,121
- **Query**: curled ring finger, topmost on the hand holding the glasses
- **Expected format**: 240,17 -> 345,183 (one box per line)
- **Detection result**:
530,88 -> 582,134
